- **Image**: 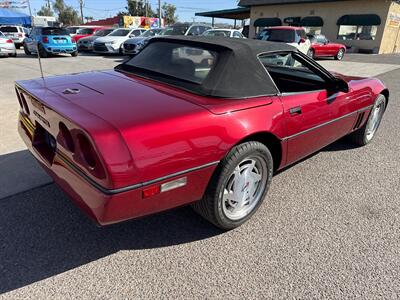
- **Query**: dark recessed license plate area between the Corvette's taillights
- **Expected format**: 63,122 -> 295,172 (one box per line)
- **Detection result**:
32,122 -> 57,165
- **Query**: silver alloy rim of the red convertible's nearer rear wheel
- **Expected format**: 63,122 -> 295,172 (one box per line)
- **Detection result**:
222,155 -> 268,221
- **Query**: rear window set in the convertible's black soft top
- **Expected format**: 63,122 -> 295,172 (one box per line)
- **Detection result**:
125,42 -> 218,84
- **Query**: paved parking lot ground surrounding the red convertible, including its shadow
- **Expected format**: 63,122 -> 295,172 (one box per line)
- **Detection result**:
0,52 -> 400,299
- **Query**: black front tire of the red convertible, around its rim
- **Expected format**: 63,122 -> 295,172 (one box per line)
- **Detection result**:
348,94 -> 387,146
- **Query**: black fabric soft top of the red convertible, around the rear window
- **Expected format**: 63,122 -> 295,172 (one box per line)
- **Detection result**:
116,36 -> 297,98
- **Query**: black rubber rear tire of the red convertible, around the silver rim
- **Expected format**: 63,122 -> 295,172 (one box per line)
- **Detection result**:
192,142 -> 273,230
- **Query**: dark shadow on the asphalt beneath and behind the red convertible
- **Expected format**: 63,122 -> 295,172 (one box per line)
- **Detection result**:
0,150 -> 222,294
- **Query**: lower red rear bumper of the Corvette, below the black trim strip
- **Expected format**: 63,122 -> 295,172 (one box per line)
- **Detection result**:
18,114 -> 216,225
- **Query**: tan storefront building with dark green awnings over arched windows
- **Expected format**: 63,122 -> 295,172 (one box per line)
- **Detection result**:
239,0 -> 400,53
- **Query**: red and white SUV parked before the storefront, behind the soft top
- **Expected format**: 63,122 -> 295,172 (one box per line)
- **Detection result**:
257,26 -> 311,54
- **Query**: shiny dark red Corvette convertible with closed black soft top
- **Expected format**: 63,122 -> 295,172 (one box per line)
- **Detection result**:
16,37 -> 389,229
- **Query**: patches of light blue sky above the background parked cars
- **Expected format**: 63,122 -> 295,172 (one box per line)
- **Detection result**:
26,0 -> 237,22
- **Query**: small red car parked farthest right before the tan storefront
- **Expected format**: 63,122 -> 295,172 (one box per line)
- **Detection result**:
308,34 -> 346,60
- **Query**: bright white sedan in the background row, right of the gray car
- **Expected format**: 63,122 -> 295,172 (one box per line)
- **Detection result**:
93,28 -> 146,54
